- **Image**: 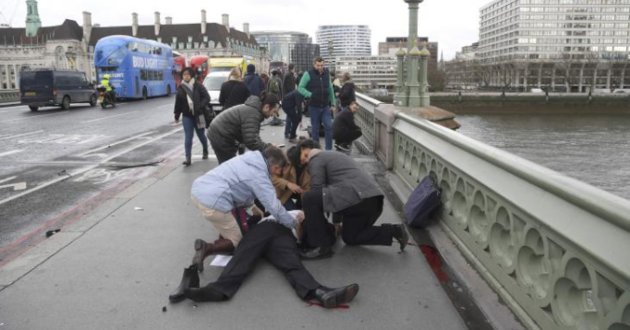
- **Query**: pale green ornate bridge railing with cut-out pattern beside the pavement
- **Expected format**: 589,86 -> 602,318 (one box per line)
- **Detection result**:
356,92 -> 630,330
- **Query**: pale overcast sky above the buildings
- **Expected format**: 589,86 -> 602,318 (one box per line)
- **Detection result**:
0,0 -> 491,60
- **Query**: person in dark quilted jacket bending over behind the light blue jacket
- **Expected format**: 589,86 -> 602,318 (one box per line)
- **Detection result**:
208,94 -> 279,164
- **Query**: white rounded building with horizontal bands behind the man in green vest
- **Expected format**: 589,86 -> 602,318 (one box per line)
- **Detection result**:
315,25 -> 372,70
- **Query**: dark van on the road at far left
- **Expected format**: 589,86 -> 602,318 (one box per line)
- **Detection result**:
20,69 -> 97,111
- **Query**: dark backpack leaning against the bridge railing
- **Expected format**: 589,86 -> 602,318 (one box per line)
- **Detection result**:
404,175 -> 442,227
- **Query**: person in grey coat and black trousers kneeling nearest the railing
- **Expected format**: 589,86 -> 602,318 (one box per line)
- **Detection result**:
298,140 -> 409,259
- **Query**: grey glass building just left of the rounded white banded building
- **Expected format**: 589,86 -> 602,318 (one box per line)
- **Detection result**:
252,31 -> 320,72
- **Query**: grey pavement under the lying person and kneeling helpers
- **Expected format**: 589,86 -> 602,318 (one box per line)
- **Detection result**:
0,114 -> 467,330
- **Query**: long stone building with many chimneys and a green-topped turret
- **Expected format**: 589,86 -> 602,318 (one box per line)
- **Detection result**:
0,0 -> 268,90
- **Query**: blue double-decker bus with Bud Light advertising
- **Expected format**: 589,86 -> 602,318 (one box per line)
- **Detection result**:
94,35 -> 175,99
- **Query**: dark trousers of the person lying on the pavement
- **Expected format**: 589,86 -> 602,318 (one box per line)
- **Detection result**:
210,221 -> 321,299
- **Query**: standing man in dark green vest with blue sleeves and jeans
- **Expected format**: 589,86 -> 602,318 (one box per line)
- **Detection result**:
298,57 -> 335,150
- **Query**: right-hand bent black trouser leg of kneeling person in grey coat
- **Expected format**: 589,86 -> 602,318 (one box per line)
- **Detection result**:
337,196 -> 394,245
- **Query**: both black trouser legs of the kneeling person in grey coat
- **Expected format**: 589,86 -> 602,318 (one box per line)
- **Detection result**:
302,190 -> 395,247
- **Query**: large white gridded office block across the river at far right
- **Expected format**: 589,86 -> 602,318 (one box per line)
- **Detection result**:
476,0 -> 630,92
